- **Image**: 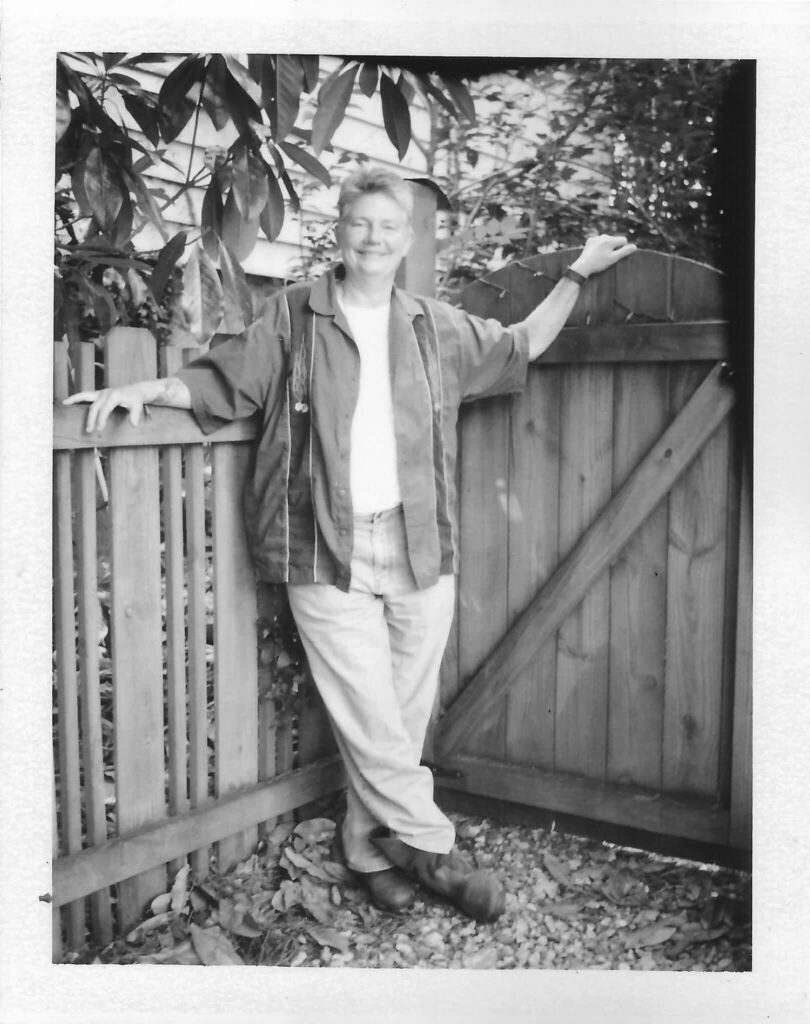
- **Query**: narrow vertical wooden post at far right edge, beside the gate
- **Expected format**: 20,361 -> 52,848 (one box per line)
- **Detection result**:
729,464 -> 754,850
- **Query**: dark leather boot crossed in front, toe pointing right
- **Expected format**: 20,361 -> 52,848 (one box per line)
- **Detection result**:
372,830 -> 506,922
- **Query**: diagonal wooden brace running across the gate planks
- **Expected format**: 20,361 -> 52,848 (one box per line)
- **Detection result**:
437,364 -> 734,755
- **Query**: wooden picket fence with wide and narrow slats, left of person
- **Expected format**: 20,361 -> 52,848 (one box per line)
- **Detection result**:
53,330 -> 343,955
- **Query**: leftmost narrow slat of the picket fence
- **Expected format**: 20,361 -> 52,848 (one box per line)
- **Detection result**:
53,344 -> 85,949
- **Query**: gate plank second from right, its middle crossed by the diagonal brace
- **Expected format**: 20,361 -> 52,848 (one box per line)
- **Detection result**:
607,253 -> 672,788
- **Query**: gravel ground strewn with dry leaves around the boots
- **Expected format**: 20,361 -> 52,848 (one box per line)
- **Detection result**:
79,814 -> 751,971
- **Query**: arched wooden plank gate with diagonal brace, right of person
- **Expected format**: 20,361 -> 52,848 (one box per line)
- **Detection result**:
432,251 -> 751,850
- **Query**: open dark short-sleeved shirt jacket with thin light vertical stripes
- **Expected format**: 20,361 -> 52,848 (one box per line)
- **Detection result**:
177,267 -> 528,590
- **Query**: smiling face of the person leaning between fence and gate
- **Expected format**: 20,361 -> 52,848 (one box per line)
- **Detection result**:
336,193 -> 413,281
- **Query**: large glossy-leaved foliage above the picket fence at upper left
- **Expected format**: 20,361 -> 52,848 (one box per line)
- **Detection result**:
54,52 -> 474,342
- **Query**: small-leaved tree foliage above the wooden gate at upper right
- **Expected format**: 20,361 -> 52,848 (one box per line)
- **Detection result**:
431,60 -> 734,296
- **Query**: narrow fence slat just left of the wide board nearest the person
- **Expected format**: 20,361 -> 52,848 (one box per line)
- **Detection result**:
185,444 -> 209,879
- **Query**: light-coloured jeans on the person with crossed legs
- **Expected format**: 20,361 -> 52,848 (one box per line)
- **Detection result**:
288,508 -> 455,871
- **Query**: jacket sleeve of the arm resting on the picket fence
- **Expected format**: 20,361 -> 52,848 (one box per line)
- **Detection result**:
175,295 -> 290,434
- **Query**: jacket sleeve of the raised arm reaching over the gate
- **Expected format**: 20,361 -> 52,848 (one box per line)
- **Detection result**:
434,302 -> 528,401
